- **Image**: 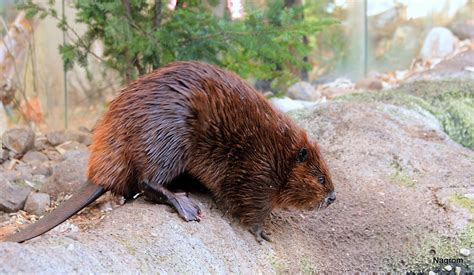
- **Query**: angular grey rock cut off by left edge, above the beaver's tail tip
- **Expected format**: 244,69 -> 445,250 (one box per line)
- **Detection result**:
0,179 -> 30,213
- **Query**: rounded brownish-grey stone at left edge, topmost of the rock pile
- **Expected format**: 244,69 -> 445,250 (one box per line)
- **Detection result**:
2,127 -> 35,155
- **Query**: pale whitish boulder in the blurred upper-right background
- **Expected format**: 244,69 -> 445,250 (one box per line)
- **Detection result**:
420,27 -> 455,60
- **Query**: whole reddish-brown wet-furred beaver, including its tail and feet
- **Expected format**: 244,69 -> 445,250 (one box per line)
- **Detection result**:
1,61 -> 336,243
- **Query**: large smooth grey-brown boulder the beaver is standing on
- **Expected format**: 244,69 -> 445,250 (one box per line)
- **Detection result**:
0,92 -> 474,274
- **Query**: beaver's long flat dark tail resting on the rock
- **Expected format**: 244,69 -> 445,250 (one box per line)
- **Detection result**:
3,181 -> 106,243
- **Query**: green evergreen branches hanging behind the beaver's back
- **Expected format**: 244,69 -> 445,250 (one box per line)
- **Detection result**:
18,0 -> 335,85
